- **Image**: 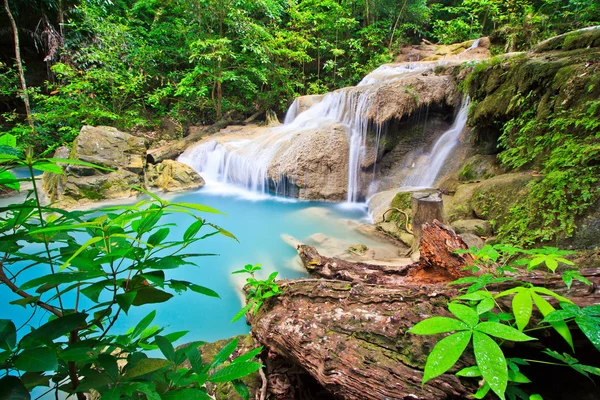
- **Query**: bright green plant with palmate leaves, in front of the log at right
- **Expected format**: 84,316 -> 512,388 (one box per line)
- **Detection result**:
408,244 -> 600,399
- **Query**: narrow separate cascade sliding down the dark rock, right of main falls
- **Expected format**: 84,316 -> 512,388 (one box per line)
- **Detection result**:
402,97 -> 470,187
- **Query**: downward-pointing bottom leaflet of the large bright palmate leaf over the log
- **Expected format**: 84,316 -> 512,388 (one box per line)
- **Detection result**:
473,329 -> 506,400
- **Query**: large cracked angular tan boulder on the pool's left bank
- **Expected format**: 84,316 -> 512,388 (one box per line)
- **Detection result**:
42,126 -> 146,204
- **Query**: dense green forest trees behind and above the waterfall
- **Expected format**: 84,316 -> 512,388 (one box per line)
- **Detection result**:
0,0 -> 600,151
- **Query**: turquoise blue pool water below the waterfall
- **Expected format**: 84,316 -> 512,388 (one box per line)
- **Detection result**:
0,187 -> 366,343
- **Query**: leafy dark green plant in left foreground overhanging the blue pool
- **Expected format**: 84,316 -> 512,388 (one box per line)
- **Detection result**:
0,135 -> 261,399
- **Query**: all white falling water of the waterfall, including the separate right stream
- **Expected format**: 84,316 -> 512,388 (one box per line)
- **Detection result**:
179,61 -> 464,203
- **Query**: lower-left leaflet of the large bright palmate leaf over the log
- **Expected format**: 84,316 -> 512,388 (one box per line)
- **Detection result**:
423,331 -> 471,384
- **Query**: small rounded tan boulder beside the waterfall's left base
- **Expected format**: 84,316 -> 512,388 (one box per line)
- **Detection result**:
146,160 -> 204,192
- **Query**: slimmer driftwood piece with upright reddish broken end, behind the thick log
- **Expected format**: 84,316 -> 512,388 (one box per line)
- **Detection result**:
298,221 -> 473,287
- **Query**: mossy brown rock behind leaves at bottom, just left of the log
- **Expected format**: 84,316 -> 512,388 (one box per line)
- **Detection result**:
179,335 -> 262,400
